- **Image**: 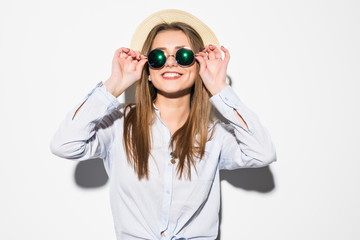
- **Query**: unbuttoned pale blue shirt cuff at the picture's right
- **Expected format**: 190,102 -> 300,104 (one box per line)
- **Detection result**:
210,86 -> 253,135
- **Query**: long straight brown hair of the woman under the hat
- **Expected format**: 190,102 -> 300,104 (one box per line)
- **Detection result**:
124,22 -> 214,180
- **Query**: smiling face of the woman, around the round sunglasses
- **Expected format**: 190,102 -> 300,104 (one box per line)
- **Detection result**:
149,30 -> 197,97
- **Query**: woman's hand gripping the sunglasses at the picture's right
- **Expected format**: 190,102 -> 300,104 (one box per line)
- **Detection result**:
195,45 -> 230,95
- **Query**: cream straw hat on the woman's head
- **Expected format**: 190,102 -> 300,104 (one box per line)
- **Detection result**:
130,9 -> 220,51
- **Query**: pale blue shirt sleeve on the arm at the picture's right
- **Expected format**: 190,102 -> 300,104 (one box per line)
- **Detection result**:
210,86 -> 276,170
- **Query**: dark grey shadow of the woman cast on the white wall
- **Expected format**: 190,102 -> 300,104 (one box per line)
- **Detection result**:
74,76 -> 275,240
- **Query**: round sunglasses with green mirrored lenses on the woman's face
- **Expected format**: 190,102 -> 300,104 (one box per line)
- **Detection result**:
148,48 -> 195,69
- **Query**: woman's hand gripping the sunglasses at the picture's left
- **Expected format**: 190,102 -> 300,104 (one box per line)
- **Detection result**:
104,47 -> 147,97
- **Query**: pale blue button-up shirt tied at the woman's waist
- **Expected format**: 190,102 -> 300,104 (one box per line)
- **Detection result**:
50,83 -> 276,240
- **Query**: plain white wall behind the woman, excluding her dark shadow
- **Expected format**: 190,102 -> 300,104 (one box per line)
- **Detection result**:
0,0 -> 360,240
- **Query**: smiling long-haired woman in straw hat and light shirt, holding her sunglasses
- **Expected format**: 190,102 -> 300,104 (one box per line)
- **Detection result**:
51,10 -> 276,240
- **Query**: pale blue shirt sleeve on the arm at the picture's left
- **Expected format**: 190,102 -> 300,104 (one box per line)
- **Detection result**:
50,82 -> 120,161
